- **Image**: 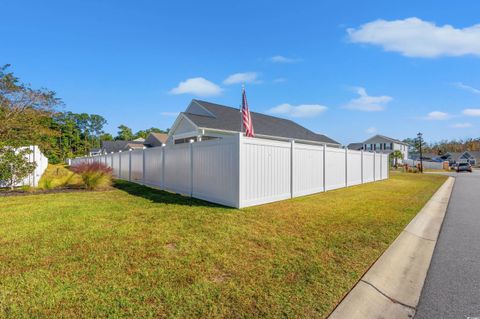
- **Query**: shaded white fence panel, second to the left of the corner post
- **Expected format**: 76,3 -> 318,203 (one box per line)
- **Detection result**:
164,143 -> 192,195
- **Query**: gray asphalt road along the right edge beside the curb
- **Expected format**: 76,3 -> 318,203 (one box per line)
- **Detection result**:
415,171 -> 480,319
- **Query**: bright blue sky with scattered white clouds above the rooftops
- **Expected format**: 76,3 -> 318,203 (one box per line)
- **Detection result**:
0,0 -> 480,143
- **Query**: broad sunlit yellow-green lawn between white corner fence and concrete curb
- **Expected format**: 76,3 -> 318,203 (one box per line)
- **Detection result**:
0,173 -> 446,318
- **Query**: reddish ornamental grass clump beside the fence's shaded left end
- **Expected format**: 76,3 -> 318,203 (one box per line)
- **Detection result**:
70,163 -> 112,190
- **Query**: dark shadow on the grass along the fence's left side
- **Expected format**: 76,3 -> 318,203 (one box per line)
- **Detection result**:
113,179 -> 225,208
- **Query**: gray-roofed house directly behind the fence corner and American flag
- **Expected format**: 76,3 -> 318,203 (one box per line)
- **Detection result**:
167,99 -> 340,147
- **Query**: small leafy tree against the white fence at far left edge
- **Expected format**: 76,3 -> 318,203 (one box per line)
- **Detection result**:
0,147 -> 37,190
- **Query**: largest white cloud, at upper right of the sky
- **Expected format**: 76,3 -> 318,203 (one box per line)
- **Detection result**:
347,17 -> 480,58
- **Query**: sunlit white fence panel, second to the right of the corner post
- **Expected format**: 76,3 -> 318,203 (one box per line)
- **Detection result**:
292,143 -> 324,197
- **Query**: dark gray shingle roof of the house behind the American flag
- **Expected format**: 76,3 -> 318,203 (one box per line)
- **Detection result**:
183,100 -> 340,144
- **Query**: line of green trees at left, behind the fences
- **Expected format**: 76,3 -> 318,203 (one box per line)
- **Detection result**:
0,65 -> 167,163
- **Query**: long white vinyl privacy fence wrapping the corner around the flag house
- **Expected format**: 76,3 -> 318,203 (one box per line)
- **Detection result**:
72,134 -> 389,208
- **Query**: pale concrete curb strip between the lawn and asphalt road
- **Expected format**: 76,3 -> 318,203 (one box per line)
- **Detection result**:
328,177 -> 455,319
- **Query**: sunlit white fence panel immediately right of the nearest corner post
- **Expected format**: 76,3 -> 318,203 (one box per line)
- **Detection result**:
240,138 -> 291,207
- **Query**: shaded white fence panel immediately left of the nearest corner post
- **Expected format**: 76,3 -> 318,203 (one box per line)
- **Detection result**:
192,138 -> 239,206
